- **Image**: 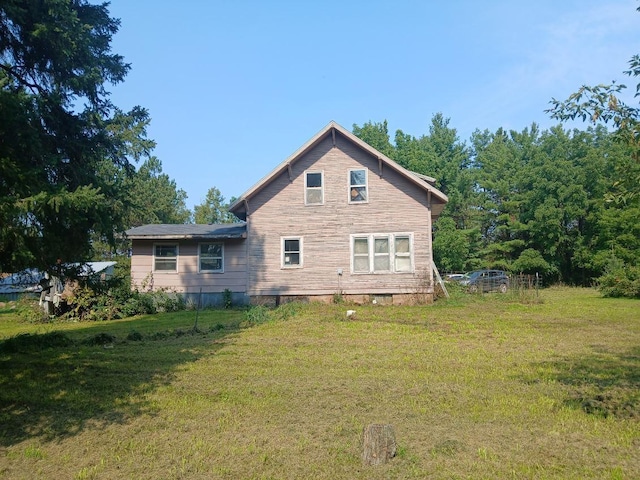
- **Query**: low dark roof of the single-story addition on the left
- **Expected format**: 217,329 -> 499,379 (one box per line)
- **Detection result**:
125,223 -> 247,240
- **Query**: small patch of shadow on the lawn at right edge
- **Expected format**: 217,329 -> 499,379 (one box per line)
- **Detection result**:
542,347 -> 640,418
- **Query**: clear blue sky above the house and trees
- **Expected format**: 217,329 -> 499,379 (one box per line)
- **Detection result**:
109,0 -> 640,208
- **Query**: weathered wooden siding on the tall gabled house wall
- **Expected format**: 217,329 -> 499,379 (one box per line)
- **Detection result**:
247,134 -> 432,295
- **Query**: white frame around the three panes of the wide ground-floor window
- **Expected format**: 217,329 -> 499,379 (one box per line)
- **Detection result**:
349,232 -> 415,275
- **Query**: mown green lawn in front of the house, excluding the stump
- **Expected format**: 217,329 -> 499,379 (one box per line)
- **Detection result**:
0,288 -> 640,479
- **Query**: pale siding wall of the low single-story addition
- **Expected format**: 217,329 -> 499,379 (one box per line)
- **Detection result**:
131,240 -> 247,293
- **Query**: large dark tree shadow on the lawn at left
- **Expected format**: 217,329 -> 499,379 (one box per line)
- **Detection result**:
0,316 -> 237,447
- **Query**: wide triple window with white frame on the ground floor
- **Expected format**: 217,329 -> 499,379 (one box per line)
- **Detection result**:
351,233 -> 413,273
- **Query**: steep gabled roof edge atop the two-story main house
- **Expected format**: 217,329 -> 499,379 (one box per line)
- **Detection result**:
229,121 -> 449,218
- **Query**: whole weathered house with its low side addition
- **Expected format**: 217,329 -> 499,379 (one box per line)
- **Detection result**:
127,122 -> 448,304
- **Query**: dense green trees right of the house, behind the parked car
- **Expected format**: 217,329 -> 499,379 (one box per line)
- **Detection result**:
353,114 -> 640,292
